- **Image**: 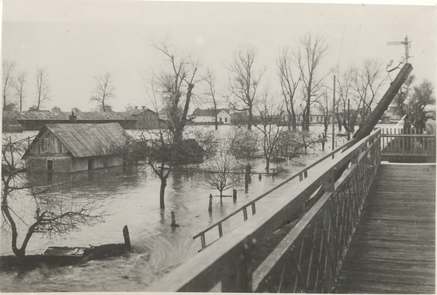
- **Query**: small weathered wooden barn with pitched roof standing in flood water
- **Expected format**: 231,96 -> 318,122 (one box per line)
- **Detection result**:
23,123 -> 129,172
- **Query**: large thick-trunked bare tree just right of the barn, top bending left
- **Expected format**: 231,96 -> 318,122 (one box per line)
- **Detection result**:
156,45 -> 199,144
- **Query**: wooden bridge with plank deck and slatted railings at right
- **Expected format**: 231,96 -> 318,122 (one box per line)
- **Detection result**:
149,130 -> 435,293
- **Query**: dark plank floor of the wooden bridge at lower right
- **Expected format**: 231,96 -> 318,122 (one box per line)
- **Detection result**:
337,164 -> 436,293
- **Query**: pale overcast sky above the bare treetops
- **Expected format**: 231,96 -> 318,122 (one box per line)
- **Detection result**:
2,0 -> 437,110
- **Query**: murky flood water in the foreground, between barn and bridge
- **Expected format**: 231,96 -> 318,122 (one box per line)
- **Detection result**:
0,124 -> 348,291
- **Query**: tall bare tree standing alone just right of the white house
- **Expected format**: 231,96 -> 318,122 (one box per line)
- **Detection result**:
230,50 -> 262,130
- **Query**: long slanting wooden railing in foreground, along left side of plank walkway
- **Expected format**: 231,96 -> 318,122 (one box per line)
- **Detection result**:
149,130 -> 381,292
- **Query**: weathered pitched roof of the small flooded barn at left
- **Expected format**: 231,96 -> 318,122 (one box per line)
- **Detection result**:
27,123 -> 129,158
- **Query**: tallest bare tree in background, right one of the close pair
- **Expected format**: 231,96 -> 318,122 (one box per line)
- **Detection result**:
296,34 -> 327,131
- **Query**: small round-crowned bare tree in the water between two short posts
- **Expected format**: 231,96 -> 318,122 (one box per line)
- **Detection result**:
208,150 -> 237,200
